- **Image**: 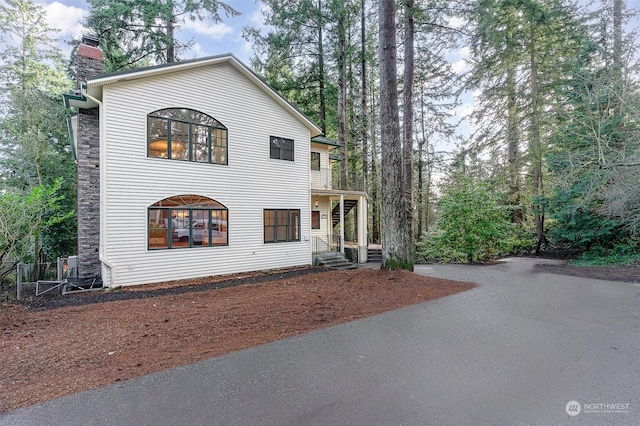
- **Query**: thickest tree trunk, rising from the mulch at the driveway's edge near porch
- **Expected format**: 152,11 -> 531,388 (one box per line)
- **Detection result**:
379,0 -> 413,270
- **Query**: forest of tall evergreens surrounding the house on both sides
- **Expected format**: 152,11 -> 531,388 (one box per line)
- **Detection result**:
0,0 -> 640,279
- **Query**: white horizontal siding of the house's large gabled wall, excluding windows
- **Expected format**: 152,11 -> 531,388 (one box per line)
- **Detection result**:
101,64 -> 311,286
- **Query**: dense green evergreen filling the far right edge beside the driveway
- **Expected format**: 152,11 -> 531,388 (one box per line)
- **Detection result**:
549,1 -> 640,243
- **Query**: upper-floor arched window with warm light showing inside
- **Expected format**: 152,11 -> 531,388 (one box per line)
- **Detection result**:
147,108 -> 228,164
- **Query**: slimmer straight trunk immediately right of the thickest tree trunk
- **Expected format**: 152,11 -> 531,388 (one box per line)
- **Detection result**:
402,0 -> 415,243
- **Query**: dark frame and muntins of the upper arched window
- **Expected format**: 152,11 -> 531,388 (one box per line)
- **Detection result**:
146,108 -> 229,165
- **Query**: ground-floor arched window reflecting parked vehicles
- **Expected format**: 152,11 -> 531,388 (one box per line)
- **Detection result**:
148,195 -> 229,250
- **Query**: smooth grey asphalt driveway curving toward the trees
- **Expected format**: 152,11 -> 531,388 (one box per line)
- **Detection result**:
0,259 -> 640,426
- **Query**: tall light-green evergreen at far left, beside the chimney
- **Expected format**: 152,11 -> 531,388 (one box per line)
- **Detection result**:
0,0 -> 76,269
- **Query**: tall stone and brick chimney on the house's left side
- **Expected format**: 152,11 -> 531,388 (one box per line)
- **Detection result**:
76,36 -> 104,279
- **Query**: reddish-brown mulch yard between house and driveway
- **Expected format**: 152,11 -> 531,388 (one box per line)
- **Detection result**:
0,268 -> 475,413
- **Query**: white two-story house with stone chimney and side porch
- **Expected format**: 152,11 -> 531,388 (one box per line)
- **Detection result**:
65,38 -> 367,286
